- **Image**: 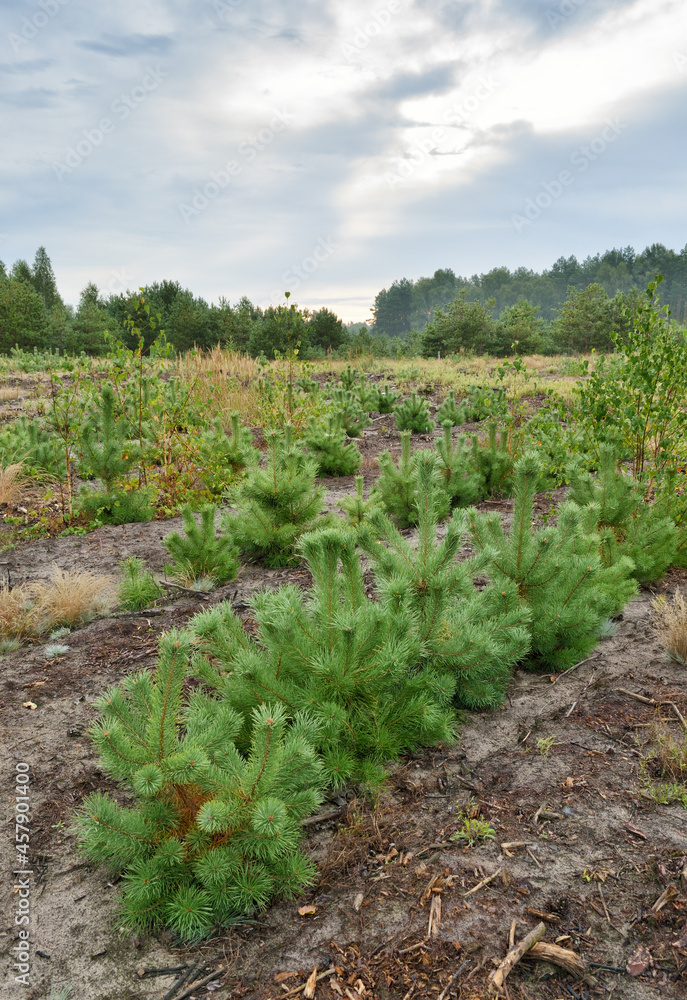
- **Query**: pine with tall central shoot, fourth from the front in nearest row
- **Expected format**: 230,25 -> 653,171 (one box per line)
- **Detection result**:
469,454 -> 637,670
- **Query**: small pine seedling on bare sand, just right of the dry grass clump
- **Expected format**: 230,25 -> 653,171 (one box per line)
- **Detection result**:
163,504 -> 239,587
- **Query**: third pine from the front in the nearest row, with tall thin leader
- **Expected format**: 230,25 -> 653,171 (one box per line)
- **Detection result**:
360,458 -> 530,708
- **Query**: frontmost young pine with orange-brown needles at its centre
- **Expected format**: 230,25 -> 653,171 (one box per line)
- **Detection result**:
78,632 -> 323,940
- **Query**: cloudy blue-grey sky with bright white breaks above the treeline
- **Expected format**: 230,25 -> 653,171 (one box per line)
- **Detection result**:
0,0 -> 687,321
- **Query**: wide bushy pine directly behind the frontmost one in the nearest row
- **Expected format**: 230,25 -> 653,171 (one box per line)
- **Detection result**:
189,528 -> 453,785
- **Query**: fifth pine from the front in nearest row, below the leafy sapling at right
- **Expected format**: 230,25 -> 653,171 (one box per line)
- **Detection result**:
568,445 -> 677,583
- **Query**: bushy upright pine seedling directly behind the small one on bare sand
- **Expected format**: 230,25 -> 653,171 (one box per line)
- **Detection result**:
225,425 -> 324,566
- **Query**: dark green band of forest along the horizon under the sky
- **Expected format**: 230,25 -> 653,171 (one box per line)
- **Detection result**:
0,244 -> 687,359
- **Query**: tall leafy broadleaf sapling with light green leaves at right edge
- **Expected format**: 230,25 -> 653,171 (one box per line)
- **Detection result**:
576,277 -> 687,479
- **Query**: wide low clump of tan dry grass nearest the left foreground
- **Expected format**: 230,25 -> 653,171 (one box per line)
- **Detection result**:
0,567 -> 113,639
